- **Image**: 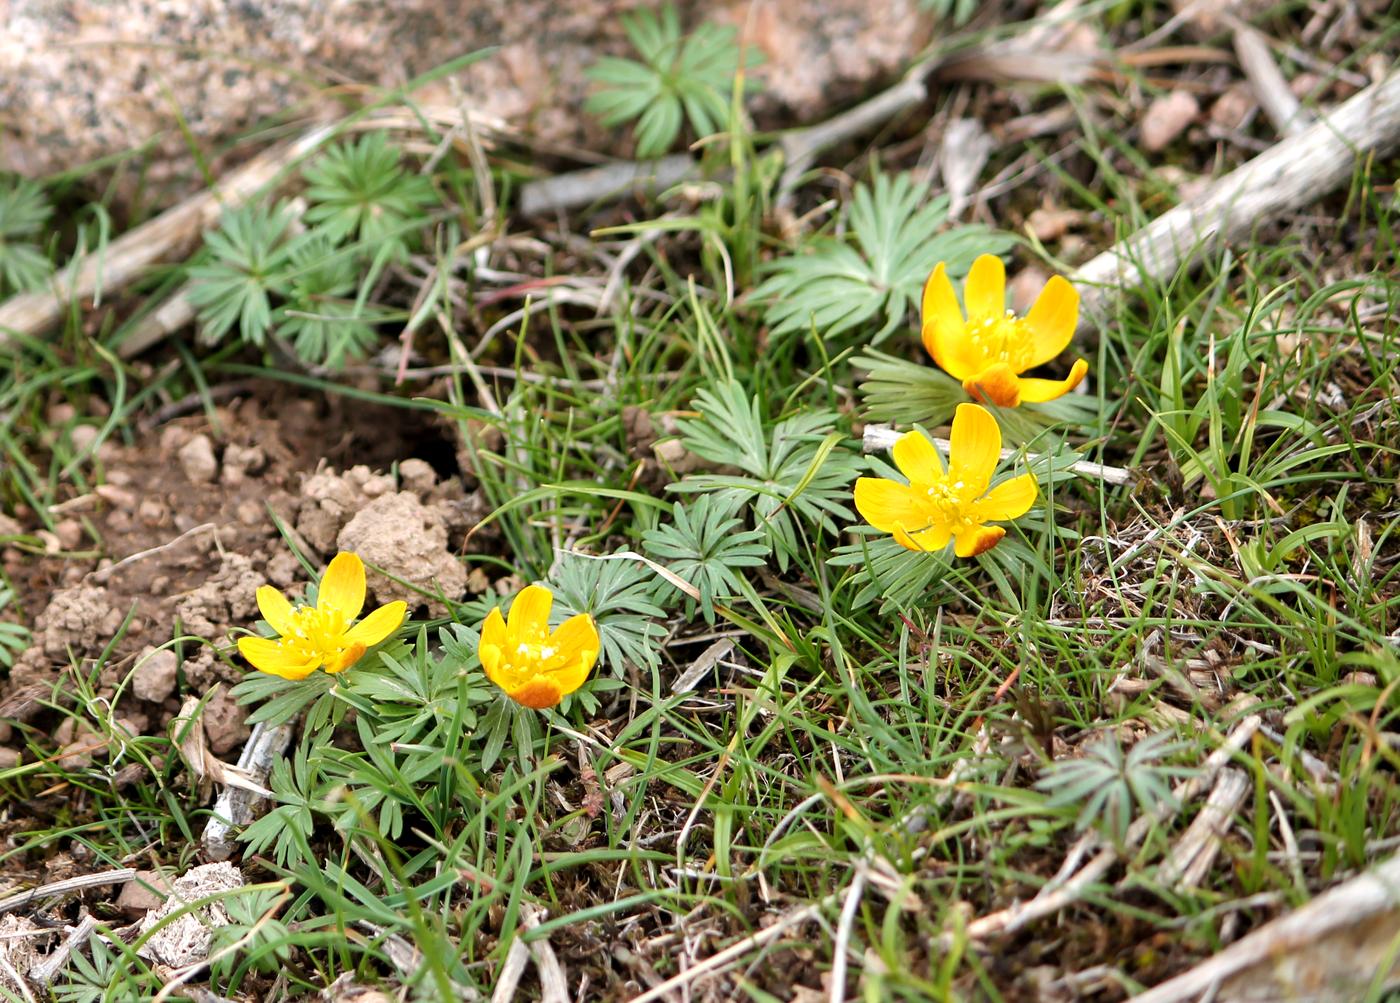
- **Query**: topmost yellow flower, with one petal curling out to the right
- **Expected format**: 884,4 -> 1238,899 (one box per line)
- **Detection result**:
923,254 -> 1089,408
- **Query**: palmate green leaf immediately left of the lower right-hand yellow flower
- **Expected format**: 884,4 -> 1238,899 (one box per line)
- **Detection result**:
666,381 -> 860,569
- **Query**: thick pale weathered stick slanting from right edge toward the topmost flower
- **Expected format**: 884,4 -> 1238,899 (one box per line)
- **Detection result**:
1074,73 -> 1400,331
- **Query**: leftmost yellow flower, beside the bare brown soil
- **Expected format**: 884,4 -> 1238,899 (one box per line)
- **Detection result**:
238,551 -> 409,679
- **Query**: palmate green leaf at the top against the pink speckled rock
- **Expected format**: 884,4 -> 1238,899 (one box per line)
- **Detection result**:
584,4 -> 759,157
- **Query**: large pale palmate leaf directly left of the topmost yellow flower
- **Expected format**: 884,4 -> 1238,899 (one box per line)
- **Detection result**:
752,172 -> 1012,345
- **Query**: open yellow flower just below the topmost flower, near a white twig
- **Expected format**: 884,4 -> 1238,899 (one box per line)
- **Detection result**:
855,403 -> 1037,558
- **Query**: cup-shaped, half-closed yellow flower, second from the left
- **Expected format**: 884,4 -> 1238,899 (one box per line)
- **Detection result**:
476,586 -> 599,710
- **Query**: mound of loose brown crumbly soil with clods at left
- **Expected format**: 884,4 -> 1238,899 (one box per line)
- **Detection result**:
0,391 -> 486,758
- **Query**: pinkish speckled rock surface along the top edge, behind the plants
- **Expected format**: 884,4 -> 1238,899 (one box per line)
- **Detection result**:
8,0 -> 930,180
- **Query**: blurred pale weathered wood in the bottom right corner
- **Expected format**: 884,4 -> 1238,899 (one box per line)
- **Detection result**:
1133,857 -> 1400,1003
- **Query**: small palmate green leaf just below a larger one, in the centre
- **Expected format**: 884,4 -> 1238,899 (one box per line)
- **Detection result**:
643,494 -> 770,623
